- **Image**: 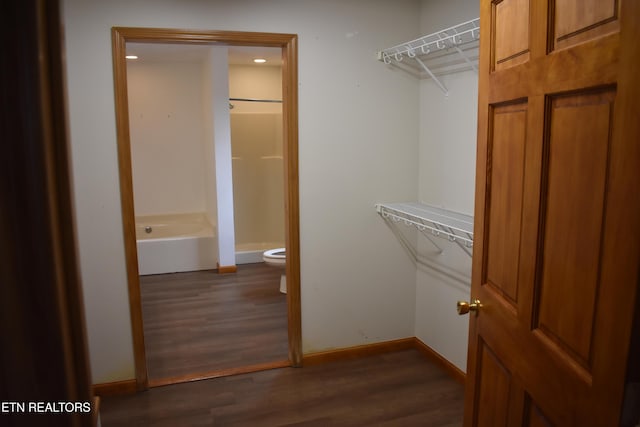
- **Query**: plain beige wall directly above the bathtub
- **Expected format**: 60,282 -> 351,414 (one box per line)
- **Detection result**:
127,60 -> 206,215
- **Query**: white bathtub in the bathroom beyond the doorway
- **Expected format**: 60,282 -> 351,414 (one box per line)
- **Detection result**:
136,213 -> 218,275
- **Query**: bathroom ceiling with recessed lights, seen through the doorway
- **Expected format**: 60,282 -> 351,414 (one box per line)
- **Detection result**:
127,43 -> 282,67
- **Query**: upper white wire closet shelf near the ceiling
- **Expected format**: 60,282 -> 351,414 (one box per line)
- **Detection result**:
378,18 -> 480,94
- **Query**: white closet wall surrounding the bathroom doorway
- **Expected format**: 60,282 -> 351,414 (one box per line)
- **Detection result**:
64,0 -> 420,383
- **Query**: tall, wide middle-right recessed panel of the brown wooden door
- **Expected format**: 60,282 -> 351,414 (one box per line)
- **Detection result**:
535,91 -> 614,371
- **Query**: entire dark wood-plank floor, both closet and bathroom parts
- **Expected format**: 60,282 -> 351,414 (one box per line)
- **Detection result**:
117,264 -> 463,427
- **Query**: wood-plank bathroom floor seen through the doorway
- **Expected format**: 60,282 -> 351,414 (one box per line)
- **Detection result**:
140,263 -> 288,385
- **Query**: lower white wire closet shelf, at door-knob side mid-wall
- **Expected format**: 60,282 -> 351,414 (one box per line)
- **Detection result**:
375,203 -> 473,256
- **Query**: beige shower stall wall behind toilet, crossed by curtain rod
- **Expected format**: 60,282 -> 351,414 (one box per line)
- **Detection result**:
229,65 -> 285,250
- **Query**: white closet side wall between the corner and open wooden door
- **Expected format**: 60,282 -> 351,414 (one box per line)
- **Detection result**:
415,0 -> 484,371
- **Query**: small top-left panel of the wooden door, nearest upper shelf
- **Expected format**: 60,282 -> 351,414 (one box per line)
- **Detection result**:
493,0 -> 529,70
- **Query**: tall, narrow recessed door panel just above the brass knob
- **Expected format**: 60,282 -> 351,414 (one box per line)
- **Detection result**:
484,103 -> 527,305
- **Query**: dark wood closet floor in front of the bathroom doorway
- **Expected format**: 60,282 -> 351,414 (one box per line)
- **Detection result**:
101,349 -> 463,427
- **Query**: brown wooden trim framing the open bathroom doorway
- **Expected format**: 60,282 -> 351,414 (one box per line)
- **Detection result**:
111,27 -> 302,390
